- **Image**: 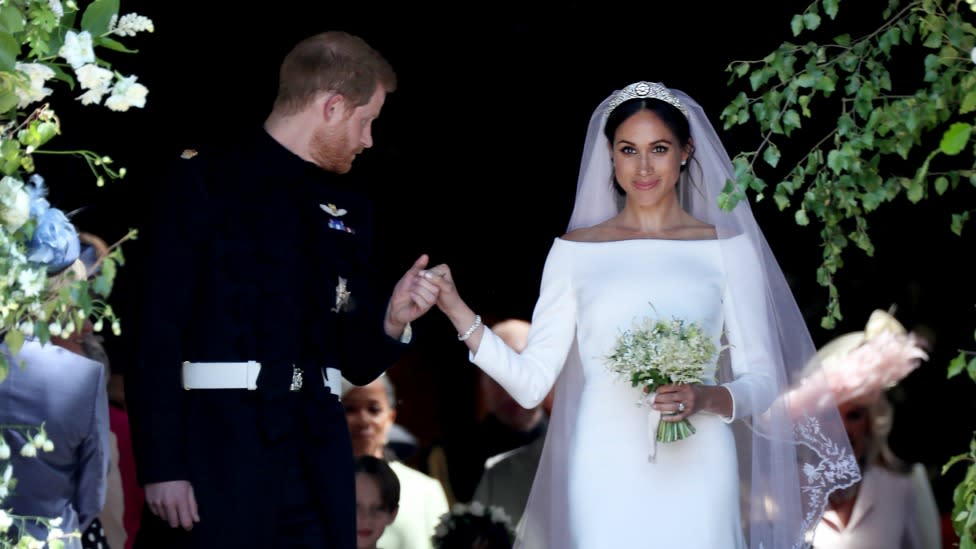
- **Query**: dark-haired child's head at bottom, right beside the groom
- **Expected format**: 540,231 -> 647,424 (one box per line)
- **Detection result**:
356,456 -> 400,549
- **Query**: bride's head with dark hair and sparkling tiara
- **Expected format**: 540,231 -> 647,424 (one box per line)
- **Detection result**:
603,86 -> 694,204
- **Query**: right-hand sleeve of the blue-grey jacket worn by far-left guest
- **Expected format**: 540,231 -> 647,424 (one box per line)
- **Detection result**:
74,362 -> 109,530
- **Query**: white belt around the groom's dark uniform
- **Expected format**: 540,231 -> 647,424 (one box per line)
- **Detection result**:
183,360 -> 342,397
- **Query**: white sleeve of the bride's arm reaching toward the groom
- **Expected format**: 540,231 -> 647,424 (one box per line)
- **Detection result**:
469,241 -> 577,408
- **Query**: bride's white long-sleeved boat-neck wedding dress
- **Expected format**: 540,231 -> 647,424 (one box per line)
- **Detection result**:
470,237 -> 775,549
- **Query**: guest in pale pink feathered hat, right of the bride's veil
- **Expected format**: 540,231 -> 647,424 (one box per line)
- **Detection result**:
812,310 -> 942,549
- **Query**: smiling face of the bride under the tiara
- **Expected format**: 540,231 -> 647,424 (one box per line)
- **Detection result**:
611,110 -> 688,206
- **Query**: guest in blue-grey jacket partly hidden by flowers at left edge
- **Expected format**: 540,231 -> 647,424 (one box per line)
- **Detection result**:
0,232 -> 110,549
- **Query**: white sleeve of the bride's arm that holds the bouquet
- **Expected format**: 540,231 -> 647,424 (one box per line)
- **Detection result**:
722,234 -> 776,422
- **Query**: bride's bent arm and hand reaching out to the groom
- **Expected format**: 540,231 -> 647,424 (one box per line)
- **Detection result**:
425,242 -> 576,408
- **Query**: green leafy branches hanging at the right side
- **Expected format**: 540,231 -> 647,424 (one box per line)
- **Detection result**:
720,0 -> 976,549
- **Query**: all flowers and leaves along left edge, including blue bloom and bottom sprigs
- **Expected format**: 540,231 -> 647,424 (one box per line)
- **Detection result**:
0,0 -> 153,549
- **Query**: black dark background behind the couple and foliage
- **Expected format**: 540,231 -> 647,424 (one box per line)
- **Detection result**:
38,0 -> 976,511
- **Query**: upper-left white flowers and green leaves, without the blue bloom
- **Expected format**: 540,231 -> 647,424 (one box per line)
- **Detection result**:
0,0 -> 153,382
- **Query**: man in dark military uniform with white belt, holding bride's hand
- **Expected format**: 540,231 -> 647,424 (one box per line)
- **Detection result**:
126,32 -> 437,549
